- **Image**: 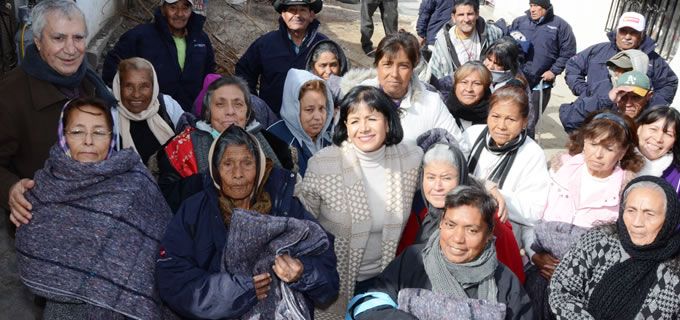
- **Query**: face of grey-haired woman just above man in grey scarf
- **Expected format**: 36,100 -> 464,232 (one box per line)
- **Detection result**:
423,160 -> 458,208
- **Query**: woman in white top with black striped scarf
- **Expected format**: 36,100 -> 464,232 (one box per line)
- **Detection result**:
463,84 -> 549,264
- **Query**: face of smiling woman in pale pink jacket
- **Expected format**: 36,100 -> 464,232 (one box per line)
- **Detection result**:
583,137 -> 626,178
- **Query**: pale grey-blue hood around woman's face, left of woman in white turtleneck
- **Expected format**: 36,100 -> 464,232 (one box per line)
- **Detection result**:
280,69 -> 334,153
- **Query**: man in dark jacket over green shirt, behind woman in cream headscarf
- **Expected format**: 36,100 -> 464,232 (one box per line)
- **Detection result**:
102,0 -> 215,112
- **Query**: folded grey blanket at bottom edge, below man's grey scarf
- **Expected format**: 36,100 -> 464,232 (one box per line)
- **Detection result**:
397,288 -> 506,320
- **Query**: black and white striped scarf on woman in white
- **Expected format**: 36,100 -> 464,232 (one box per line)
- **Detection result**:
468,127 -> 527,189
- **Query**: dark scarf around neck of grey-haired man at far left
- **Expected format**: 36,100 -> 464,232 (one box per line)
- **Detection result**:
21,44 -> 116,105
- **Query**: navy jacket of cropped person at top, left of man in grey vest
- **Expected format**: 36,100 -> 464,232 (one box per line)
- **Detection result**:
416,0 -> 453,45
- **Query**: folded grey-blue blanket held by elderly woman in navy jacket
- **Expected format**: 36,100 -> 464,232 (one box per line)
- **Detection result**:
222,209 -> 329,320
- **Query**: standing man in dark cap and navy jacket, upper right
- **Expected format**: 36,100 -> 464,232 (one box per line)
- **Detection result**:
510,0 -> 576,131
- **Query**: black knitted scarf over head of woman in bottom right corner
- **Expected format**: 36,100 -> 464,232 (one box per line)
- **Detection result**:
588,176 -> 680,320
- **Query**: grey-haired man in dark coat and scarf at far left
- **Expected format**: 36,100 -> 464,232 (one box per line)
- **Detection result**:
0,0 -> 116,225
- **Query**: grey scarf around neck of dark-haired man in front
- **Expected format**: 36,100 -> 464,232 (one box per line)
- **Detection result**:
423,230 -> 498,302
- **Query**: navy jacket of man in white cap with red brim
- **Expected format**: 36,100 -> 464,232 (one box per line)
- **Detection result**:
566,32 -> 678,106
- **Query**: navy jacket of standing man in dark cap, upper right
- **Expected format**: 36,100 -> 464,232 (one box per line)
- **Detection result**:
510,6 -> 576,88
